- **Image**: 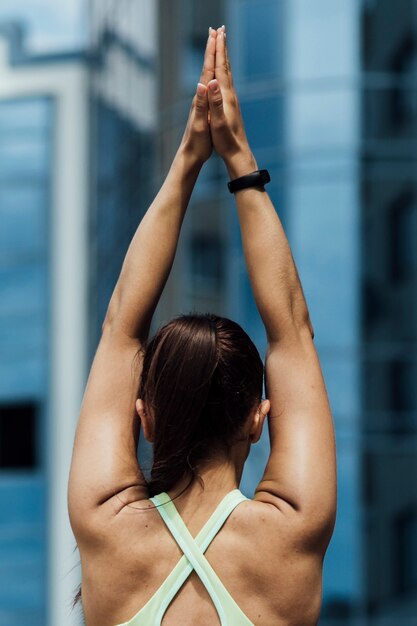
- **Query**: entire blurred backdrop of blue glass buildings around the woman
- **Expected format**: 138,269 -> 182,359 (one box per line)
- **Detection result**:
0,0 -> 417,626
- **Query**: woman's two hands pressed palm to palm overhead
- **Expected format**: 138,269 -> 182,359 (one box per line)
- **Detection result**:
182,26 -> 250,164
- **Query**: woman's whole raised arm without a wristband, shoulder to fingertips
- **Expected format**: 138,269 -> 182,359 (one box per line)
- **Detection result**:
68,31 -> 216,542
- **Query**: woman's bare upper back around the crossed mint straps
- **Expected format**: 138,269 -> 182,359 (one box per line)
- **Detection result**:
80,497 -> 323,626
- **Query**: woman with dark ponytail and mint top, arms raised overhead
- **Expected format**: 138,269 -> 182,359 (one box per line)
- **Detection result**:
68,27 -> 336,626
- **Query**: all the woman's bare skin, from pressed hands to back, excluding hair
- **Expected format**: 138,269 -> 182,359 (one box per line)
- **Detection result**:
68,28 -> 337,626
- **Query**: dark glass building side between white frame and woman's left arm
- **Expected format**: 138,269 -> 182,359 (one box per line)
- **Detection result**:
89,0 -> 156,359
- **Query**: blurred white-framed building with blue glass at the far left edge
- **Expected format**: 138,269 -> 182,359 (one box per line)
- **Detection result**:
0,23 -> 88,626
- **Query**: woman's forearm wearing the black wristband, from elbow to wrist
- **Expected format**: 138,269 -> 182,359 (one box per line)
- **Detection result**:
226,151 -> 314,343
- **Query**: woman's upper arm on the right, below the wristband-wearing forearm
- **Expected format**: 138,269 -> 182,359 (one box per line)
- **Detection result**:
255,326 -> 337,543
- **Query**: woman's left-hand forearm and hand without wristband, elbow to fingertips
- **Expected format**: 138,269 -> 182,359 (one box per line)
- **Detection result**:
104,30 -> 216,340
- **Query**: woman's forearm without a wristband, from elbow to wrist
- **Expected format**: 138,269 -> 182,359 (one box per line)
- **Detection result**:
103,146 -> 202,340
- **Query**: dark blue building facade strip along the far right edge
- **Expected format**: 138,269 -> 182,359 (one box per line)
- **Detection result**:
361,0 -> 417,626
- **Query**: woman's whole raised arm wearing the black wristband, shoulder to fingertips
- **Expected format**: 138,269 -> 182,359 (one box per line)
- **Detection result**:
209,26 -> 337,550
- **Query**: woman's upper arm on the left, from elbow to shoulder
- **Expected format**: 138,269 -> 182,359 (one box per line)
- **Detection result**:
68,327 -> 147,534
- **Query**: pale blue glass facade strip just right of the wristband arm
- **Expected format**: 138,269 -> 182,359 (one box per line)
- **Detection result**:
283,0 -> 363,624
